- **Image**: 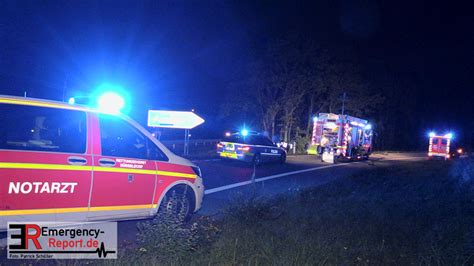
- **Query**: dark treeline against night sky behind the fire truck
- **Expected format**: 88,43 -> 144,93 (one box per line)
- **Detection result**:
221,38 -> 427,150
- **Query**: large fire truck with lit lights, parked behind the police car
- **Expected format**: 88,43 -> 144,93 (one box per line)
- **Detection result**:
307,113 -> 373,163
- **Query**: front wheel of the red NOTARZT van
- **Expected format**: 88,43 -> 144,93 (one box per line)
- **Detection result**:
158,185 -> 195,223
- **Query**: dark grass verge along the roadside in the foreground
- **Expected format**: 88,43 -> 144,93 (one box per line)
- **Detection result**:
1,161 -> 474,265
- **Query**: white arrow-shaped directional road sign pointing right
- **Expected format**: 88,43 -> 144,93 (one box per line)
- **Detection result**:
148,110 -> 204,129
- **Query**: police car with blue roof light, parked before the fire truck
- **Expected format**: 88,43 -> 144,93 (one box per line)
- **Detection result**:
217,130 -> 286,165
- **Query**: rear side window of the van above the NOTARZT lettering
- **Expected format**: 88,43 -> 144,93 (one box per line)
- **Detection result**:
0,104 -> 87,154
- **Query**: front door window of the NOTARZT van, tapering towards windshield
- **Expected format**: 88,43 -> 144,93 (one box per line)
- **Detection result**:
99,114 -> 168,161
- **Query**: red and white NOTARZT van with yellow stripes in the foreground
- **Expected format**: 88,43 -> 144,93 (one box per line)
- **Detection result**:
0,96 -> 204,230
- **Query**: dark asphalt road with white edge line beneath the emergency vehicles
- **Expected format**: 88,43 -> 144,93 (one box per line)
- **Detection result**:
0,153 -> 426,249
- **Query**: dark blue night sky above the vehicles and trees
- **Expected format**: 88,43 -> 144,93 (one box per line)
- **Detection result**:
0,0 -> 474,143
